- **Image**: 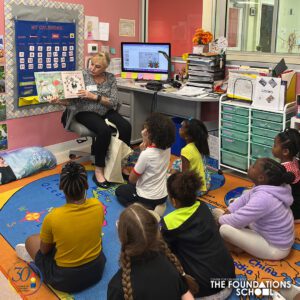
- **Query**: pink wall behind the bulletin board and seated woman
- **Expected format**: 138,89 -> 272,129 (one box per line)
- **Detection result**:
0,0 -> 140,149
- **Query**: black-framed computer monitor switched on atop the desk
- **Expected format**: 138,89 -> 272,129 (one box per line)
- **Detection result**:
121,43 -> 171,74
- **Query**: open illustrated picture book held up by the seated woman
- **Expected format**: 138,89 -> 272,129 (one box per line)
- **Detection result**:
34,71 -> 85,103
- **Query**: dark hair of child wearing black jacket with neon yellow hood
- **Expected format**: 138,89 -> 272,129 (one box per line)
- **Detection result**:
167,171 -> 202,207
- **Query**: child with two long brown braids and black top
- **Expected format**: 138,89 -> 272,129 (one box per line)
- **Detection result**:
107,203 -> 198,300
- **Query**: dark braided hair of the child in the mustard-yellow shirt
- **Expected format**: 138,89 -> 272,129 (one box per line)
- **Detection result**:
59,162 -> 89,201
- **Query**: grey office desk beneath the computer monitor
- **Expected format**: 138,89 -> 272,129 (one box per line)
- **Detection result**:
118,82 -> 219,144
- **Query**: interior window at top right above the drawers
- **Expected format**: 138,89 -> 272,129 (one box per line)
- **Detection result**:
215,0 -> 300,56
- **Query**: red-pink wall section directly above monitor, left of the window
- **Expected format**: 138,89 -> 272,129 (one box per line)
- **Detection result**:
148,0 -> 202,56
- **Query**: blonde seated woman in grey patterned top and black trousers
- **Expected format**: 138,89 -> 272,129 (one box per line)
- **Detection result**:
70,52 -> 131,189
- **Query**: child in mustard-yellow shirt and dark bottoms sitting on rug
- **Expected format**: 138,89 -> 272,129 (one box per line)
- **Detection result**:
16,162 -> 106,293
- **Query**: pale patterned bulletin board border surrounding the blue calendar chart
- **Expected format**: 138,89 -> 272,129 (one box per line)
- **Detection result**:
4,0 -> 84,119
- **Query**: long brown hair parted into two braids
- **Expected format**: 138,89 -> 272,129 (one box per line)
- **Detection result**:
118,204 -> 198,300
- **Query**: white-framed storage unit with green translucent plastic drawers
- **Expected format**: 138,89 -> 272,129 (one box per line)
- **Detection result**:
219,97 -> 295,173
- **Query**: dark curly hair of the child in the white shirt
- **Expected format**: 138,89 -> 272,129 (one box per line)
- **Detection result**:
144,113 -> 175,150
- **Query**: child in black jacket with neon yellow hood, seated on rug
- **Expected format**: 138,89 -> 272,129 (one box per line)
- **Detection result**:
161,172 -> 235,300
